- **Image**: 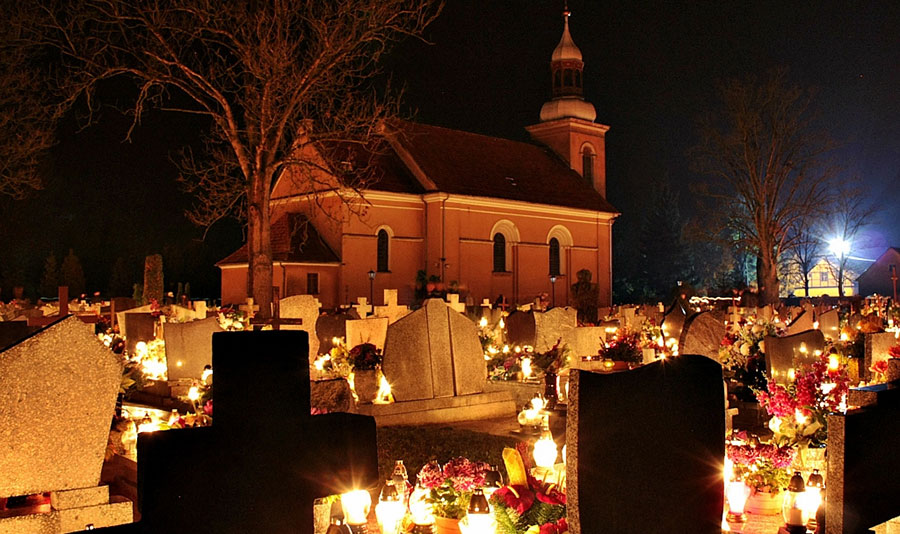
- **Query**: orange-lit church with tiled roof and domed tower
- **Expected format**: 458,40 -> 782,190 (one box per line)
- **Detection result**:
217,12 -> 618,308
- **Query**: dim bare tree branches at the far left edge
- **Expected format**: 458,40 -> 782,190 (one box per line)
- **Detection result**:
0,2 -> 56,199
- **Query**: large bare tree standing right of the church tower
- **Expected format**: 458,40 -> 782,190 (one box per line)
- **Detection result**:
692,70 -> 831,304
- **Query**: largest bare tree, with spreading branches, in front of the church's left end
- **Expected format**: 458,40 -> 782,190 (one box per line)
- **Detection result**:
34,0 -> 440,317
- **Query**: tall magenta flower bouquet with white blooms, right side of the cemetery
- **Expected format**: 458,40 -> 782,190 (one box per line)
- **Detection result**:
756,354 -> 850,445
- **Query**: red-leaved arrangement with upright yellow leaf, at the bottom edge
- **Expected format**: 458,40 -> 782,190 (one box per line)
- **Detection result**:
490,444 -> 569,534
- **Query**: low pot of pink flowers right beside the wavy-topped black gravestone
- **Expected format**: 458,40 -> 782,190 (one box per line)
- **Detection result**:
725,431 -> 796,493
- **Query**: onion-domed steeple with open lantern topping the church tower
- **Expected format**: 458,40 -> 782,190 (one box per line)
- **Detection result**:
541,6 -> 597,121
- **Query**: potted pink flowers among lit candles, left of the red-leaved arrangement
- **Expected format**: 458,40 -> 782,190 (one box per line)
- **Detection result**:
418,456 -> 491,519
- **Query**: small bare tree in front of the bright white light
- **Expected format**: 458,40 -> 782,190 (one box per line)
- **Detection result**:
823,179 -> 875,297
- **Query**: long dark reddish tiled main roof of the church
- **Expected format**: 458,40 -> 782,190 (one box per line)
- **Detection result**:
380,121 -> 617,213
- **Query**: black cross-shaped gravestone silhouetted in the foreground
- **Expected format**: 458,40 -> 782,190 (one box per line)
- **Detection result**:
95,331 -> 378,534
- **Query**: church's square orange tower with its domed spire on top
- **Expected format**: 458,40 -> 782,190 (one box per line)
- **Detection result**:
526,9 -> 609,198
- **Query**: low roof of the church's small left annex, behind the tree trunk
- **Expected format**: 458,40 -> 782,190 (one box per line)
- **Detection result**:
216,213 -> 340,265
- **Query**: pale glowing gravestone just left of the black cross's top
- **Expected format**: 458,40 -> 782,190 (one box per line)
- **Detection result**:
163,317 -> 222,380
